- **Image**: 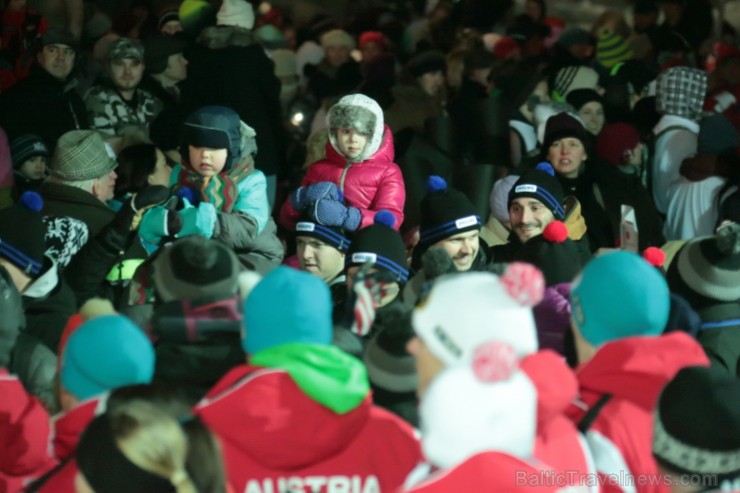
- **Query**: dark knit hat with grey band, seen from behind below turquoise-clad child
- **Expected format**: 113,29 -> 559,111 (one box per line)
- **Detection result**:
154,235 -> 240,302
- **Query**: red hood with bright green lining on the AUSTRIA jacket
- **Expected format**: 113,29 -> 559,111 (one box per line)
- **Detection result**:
195,344 -> 371,471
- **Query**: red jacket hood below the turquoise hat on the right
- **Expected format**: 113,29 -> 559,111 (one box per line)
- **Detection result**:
576,332 -> 709,409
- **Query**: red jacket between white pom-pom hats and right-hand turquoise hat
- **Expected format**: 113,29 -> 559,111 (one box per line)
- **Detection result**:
521,350 -> 598,491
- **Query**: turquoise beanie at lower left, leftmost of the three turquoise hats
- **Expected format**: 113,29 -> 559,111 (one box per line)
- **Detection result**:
59,315 -> 154,400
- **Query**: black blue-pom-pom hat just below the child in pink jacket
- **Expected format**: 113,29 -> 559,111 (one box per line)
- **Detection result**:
344,210 -> 409,283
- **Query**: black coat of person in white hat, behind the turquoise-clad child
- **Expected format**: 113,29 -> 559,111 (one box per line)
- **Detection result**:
180,26 -> 285,176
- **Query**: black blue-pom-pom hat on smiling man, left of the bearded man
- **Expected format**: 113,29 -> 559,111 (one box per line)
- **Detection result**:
419,176 -> 481,246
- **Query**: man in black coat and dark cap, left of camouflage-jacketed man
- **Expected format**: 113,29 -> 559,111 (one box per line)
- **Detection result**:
0,29 -> 89,149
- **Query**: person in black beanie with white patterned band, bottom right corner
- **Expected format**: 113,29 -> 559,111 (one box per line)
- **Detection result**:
653,366 -> 740,493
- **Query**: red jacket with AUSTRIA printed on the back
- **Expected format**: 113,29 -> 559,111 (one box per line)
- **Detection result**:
195,365 -> 421,493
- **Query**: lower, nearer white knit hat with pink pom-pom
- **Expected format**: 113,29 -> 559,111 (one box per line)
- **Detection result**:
420,342 -> 537,468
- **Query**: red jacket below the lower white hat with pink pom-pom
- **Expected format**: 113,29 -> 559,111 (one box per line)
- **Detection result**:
403,452 -> 558,493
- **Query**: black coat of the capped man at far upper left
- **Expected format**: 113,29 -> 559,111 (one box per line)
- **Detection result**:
0,66 -> 89,151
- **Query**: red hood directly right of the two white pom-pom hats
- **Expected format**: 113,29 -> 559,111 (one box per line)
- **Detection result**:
521,349 -> 578,430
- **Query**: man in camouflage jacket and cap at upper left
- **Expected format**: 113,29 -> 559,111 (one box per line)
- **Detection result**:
85,38 -> 162,140
